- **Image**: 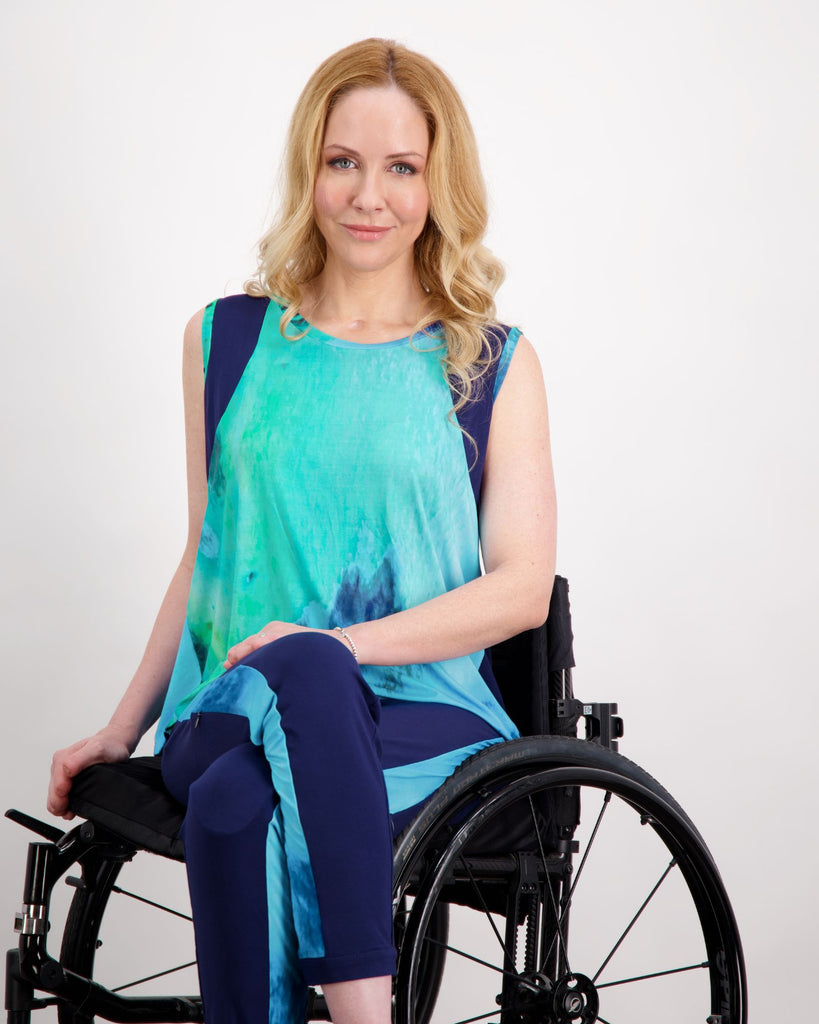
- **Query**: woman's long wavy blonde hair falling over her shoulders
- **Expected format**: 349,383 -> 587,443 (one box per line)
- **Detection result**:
245,39 -> 504,410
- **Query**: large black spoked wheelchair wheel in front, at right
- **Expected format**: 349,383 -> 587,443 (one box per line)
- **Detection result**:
395,737 -> 746,1024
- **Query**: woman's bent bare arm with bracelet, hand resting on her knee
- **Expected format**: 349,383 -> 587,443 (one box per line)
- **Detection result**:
226,337 -> 556,665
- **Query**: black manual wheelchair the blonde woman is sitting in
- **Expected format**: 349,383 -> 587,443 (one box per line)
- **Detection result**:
6,578 -> 747,1024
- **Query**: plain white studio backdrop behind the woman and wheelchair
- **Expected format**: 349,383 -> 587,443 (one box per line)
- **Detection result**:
0,0 -> 819,1022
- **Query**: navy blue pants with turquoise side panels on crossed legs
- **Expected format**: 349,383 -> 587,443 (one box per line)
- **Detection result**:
162,633 -> 502,1024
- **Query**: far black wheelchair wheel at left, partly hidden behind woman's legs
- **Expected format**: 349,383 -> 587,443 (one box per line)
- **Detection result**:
57,849 -> 203,1024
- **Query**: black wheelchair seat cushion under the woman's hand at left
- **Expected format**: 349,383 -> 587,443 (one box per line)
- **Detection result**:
70,757 -> 185,860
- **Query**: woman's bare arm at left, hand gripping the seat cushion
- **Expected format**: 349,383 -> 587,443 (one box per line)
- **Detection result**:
48,310 -> 208,818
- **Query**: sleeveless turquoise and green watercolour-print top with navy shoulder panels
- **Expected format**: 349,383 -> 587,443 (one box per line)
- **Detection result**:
156,295 -> 520,751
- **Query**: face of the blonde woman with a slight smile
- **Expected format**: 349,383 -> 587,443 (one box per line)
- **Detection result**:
313,86 -> 429,272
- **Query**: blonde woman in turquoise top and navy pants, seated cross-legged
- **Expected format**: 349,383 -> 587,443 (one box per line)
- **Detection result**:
49,39 -> 555,1024
